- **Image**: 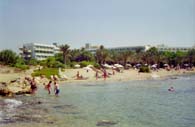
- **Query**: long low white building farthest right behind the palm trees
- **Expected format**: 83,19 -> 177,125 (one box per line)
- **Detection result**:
156,45 -> 195,52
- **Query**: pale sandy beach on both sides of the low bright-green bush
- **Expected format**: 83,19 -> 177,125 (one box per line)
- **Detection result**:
0,67 -> 195,84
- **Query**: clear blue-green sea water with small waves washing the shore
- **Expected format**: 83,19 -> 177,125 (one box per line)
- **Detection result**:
0,75 -> 195,127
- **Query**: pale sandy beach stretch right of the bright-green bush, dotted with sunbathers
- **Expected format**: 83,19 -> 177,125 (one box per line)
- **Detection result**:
59,69 -> 195,82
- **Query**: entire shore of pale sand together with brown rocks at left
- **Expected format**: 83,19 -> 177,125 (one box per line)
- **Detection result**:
0,68 -> 195,96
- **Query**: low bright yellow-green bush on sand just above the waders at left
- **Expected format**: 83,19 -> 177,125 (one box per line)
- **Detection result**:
31,68 -> 59,78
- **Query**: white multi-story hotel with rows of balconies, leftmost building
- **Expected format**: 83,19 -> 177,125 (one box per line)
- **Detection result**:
20,43 -> 60,60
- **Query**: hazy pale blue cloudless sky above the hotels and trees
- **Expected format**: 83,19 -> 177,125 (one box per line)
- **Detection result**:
0,0 -> 195,51
